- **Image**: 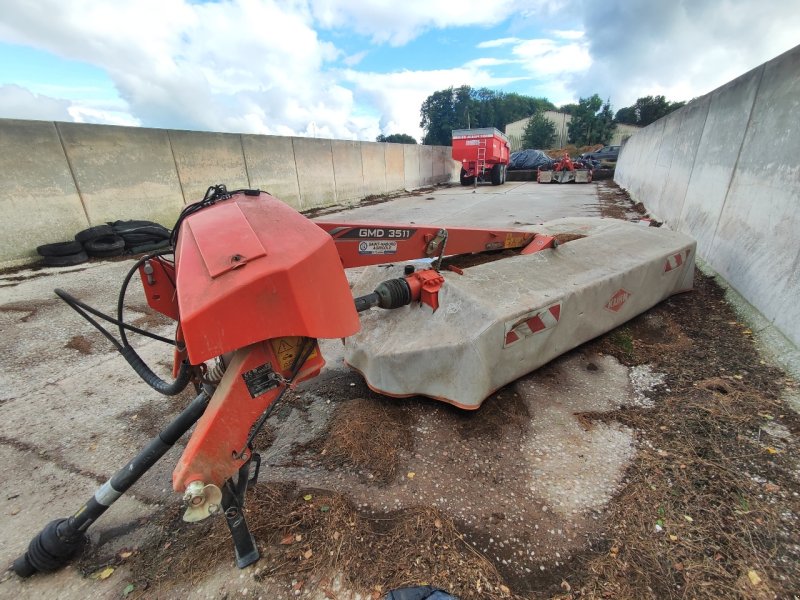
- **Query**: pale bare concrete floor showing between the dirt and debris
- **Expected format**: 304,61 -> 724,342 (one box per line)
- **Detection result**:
0,182 -> 648,598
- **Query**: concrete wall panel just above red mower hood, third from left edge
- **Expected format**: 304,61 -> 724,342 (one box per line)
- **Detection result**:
169,130 -> 250,203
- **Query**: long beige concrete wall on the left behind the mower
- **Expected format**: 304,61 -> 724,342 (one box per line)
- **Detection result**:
0,119 -> 450,268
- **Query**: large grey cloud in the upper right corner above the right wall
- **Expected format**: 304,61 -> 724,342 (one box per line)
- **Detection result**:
570,0 -> 800,109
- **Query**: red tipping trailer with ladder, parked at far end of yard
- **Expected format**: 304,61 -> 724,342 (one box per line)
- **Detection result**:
452,127 -> 511,185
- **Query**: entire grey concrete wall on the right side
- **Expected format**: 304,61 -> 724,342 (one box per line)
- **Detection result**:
615,46 -> 800,345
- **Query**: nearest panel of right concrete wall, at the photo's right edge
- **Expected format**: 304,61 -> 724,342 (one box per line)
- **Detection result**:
709,48 -> 800,345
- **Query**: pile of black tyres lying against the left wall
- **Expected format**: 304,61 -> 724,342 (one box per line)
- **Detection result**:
36,221 -> 170,267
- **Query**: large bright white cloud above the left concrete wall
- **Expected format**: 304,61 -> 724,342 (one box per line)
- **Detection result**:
0,0 -> 361,138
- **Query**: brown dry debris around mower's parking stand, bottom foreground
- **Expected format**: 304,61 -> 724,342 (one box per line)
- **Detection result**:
104,485 -> 509,600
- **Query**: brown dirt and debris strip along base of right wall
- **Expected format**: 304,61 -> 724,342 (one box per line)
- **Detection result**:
569,274 -> 800,598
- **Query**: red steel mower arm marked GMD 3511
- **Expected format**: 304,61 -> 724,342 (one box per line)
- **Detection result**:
315,221 -> 536,268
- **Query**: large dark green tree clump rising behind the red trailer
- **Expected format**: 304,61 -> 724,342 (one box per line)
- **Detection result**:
419,85 -> 555,146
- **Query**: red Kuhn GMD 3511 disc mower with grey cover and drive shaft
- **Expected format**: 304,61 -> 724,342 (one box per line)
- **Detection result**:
13,186 -> 695,577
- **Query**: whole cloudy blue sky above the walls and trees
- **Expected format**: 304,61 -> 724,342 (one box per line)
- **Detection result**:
0,0 -> 800,140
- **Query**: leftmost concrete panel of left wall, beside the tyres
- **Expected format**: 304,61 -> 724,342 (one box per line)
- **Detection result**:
0,120 -> 89,266
